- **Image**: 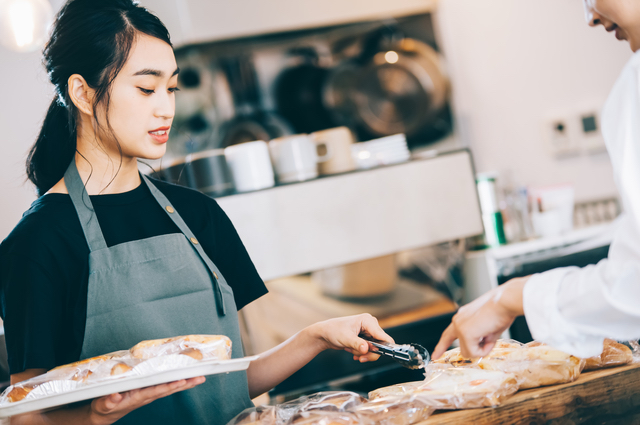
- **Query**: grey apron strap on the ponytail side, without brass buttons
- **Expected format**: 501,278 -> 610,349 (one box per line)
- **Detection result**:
64,158 -> 107,252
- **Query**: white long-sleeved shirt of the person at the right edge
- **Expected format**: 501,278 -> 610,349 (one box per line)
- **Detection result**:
523,52 -> 640,357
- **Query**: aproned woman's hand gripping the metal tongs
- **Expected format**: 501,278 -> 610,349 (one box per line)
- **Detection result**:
310,313 -> 394,363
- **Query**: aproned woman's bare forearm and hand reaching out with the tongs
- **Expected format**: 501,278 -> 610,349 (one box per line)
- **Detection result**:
247,314 -> 393,398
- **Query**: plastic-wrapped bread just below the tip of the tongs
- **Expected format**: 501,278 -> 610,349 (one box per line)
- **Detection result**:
369,364 -> 518,409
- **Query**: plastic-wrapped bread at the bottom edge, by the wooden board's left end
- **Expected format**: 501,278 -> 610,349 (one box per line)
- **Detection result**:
353,397 -> 435,425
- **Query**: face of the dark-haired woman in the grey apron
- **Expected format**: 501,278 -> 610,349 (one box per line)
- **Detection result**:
103,34 -> 178,159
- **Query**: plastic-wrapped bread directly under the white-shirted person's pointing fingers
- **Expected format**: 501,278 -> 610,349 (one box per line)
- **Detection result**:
434,340 -> 585,389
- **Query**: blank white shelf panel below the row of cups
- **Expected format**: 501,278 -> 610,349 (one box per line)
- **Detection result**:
217,150 -> 483,280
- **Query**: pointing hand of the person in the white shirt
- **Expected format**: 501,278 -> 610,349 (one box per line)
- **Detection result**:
432,277 -> 528,360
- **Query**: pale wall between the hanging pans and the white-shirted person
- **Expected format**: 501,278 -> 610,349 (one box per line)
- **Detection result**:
438,0 -> 631,200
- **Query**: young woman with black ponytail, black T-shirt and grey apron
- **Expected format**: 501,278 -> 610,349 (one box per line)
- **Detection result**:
0,0 -> 391,424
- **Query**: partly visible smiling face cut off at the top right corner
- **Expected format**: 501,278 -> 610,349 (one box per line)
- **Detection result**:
584,0 -> 640,52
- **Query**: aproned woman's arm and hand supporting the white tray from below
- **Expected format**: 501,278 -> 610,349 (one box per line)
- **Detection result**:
11,369 -> 205,425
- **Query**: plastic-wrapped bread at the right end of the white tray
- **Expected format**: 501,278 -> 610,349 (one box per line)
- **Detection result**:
129,335 -> 231,360
